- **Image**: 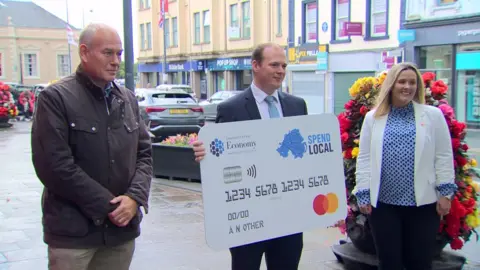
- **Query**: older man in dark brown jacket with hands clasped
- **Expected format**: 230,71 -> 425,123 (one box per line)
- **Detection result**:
32,24 -> 152,270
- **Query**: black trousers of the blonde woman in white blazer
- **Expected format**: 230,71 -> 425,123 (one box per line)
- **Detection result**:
369,202 -> 440,270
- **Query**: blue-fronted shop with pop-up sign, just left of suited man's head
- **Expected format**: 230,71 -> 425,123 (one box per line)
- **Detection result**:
207,57 -> 253,92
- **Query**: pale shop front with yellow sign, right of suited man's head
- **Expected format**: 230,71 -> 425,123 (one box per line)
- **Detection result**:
284,43 -> 329,114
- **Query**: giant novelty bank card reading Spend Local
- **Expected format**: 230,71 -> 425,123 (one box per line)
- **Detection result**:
199,114 -> 347,249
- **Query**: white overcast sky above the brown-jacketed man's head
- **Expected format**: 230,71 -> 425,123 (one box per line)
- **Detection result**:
27,0 -> 138,61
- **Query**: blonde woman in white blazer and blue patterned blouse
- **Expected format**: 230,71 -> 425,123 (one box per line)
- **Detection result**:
353,63 -> 456,270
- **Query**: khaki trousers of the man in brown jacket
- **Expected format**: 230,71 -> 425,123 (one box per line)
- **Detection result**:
48,240 -> 135,270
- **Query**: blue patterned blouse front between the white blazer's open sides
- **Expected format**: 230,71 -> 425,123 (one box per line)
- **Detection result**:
378,102 -> 416,206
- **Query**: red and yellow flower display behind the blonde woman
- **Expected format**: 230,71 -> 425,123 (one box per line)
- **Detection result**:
338,72 -> 480,249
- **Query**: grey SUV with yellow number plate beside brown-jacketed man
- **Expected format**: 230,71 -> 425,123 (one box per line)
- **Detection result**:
135,89 -> 205,141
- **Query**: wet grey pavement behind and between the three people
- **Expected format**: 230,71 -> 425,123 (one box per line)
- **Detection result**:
0,122 -> 480,270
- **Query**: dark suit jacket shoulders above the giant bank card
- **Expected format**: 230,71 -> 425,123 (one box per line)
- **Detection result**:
215,87 -> 308,123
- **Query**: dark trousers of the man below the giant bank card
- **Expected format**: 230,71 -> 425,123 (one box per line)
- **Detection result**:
230,233 -> 303,270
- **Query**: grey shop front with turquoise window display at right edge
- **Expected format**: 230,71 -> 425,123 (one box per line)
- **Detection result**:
405,22 -> 480,126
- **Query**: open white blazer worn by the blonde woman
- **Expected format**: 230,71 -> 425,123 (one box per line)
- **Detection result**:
353,102 -> 455,207
